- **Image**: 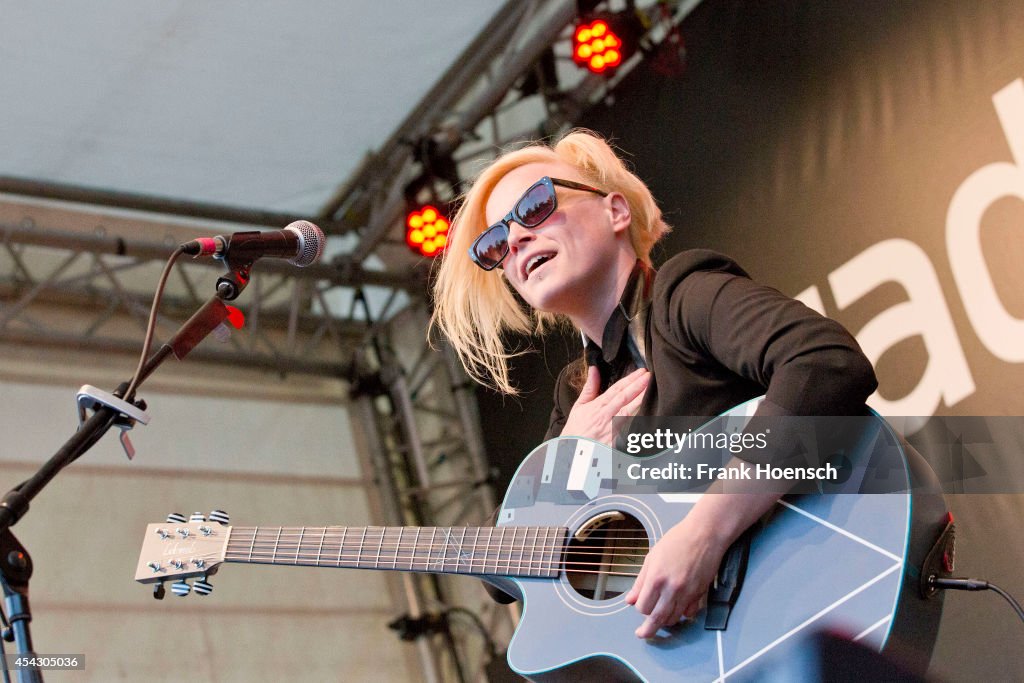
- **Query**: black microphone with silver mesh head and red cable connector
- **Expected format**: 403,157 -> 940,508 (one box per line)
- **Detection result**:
181,220 -> 327,268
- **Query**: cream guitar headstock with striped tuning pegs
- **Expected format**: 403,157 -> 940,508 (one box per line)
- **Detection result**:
135,510 -> 231,597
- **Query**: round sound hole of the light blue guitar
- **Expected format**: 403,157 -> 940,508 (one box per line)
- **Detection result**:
565,513 -> 650,600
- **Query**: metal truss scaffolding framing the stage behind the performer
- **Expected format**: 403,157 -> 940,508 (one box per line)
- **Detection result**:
0,0 -> 698,681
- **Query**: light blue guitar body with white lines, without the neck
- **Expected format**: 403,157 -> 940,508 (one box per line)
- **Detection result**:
498,401 -> 945,681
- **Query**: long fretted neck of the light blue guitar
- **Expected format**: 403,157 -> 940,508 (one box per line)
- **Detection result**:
224,526 -> 567,578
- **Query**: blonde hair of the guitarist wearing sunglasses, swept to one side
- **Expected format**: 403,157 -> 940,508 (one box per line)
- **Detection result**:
430,130 -> 670,395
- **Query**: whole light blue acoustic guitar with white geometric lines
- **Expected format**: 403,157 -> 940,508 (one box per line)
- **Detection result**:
135,401 -> 946,681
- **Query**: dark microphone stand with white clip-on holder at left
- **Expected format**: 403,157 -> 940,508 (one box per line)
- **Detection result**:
0,261 -> 252,683
